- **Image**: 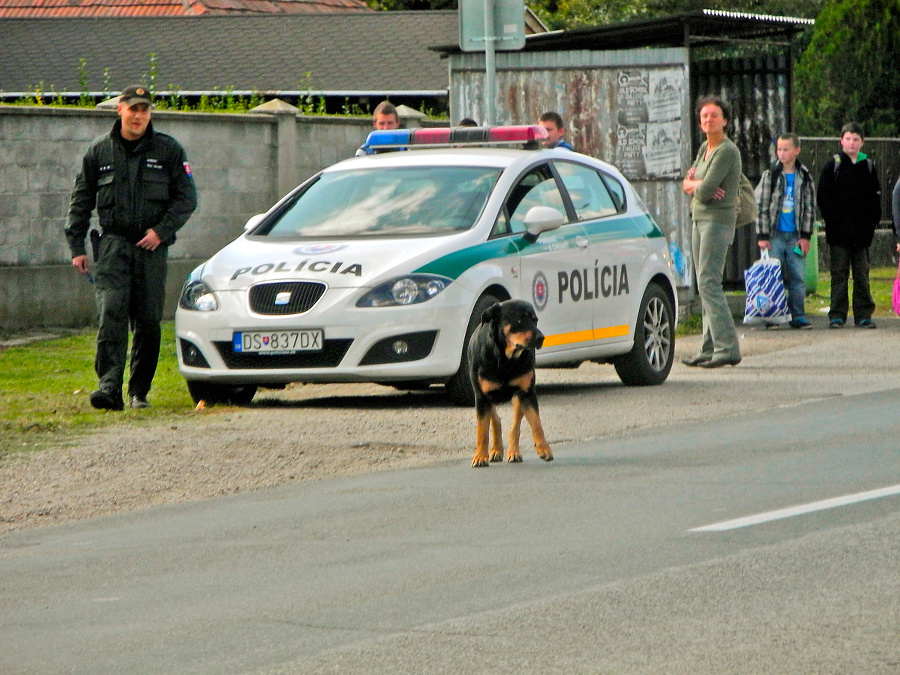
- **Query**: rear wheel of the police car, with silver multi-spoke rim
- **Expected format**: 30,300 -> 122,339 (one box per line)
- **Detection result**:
613,283 -> 675,387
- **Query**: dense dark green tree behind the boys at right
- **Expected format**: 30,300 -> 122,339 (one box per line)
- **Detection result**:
794,0 -> 900,136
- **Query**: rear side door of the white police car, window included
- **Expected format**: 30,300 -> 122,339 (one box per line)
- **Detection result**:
554,161 -> 647,344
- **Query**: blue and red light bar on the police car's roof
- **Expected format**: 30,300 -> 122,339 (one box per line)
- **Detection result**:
363,124 -> 547,155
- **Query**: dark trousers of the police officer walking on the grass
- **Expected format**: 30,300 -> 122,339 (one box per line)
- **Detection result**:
94,234 -> 168,398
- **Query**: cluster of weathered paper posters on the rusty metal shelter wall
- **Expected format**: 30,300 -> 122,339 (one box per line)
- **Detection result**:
616,68 -> 685,180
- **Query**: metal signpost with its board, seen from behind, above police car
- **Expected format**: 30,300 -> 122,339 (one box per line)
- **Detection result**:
459,0 -> 525,126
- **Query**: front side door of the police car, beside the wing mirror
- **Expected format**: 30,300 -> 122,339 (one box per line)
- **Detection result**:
495,162 -> 592,356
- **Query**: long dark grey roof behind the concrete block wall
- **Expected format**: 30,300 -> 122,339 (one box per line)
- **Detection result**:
0,11 -> 459,96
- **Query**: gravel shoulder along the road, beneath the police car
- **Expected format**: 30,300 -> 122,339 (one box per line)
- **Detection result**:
0,317 -> 900,534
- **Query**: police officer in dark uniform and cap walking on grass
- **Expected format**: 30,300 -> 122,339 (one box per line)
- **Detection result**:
65,85 -> 197,410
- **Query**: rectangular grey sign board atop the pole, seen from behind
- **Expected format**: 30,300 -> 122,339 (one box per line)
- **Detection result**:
459,0 -> 525,52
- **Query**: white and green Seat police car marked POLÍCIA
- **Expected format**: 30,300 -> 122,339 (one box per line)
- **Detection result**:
175,126 -> 677,404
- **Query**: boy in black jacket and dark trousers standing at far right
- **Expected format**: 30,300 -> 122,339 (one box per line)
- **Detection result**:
818,122 -> 881,328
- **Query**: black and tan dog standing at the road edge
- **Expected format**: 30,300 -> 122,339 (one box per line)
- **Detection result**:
469,300 -> 553,467
